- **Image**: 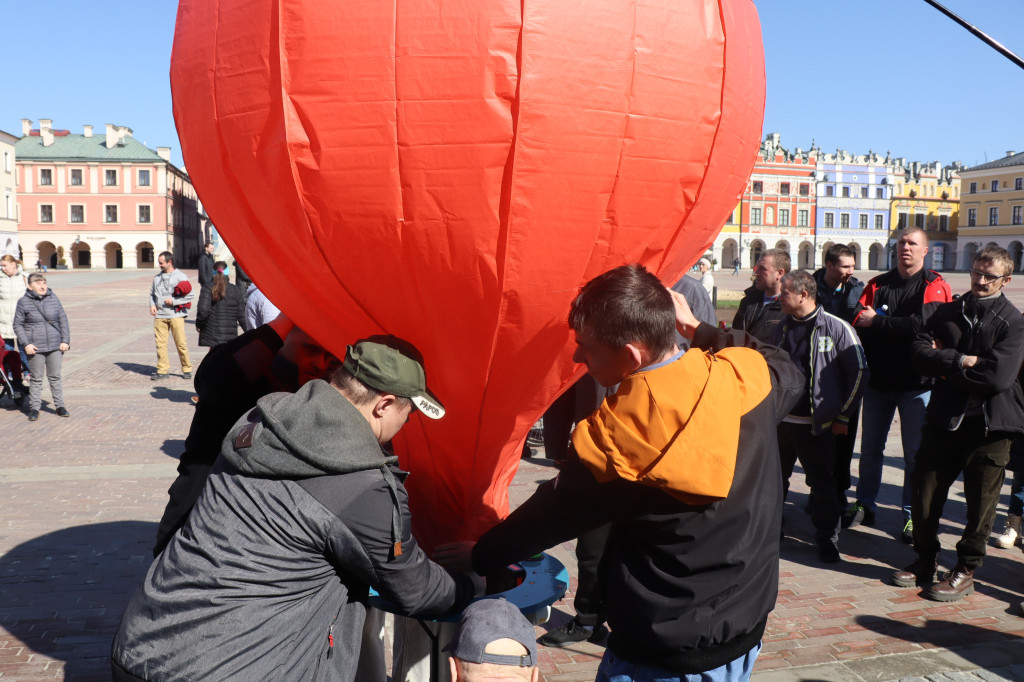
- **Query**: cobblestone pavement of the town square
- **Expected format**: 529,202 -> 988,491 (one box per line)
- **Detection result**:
0,271 -> 1024,682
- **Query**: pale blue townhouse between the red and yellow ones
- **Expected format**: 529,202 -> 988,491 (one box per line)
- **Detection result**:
816,150 -> 896,270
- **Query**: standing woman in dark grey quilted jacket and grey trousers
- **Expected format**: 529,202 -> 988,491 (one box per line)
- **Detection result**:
14,272 -> 71,422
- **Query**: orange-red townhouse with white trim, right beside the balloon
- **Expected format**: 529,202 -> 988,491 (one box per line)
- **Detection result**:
713,133 -> 819,268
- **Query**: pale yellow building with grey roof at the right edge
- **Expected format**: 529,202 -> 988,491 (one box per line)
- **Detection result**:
956,152 -> 1024,272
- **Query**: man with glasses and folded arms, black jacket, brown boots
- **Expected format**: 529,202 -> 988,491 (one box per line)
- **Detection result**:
892,246 -> 1024,601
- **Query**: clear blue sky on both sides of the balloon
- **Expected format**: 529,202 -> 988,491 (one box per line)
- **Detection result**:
0,0 -> 1024,165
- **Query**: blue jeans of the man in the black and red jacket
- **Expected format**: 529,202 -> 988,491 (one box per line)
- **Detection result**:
857,386 -> 932,518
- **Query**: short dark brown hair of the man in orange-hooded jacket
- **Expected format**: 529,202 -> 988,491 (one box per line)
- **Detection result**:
568,263 -> 676,356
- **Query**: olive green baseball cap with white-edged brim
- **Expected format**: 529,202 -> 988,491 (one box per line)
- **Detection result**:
342,335 -> 444,419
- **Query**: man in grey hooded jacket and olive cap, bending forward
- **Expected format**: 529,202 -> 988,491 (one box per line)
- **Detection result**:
111,337 -> 474,680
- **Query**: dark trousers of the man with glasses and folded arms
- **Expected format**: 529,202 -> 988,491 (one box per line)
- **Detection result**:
910,416 -> 1013,569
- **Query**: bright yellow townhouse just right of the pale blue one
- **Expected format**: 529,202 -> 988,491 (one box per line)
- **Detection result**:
889,159 -> 963,270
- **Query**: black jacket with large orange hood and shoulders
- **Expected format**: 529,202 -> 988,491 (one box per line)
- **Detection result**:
473,324 -> 805,674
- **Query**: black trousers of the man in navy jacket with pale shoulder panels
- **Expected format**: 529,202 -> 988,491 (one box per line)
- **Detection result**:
778,422 -> 842,545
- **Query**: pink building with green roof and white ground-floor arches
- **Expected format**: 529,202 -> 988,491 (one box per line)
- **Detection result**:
15,119 -> 203,269
